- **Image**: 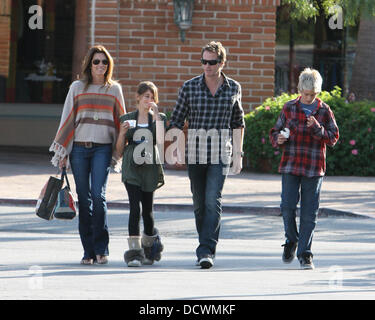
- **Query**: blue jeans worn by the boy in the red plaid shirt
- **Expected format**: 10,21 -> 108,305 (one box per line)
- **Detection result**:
280,173 -> 323,257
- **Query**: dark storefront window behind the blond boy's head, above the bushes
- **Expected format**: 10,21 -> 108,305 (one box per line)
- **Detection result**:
275,6 -> 358,95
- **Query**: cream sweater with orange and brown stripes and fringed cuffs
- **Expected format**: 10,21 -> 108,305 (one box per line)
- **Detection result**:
49,80 -> 125,166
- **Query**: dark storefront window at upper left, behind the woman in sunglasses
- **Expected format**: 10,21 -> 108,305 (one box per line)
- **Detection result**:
6,0 -> 75,103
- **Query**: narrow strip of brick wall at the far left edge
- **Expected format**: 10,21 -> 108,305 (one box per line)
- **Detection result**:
0,0 -> 10,77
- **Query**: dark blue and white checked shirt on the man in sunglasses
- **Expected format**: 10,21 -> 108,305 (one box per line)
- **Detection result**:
170,73 -> 245,164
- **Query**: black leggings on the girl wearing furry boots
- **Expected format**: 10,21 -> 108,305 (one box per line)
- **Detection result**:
125,183 -> 154,236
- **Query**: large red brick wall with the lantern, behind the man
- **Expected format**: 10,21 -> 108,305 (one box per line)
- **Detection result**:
89,0 -> 279,112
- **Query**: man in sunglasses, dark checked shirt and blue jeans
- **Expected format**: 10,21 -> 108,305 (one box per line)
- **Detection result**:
170,41 -> 245,269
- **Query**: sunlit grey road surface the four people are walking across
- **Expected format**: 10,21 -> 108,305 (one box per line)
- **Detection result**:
0,206 -> 375,300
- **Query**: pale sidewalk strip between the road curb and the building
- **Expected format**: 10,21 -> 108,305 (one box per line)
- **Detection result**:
0,151 -> 375,217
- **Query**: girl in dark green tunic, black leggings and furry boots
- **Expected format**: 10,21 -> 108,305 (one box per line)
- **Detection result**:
116,81 -> 166,267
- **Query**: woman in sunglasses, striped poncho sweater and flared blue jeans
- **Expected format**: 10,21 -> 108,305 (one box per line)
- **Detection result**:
50,45 -> 125,265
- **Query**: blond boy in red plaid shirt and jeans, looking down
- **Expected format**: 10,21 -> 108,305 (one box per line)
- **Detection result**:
270,68 -> 339,269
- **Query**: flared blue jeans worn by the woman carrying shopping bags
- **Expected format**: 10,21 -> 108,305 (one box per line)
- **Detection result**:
70,144 -> 112,259
